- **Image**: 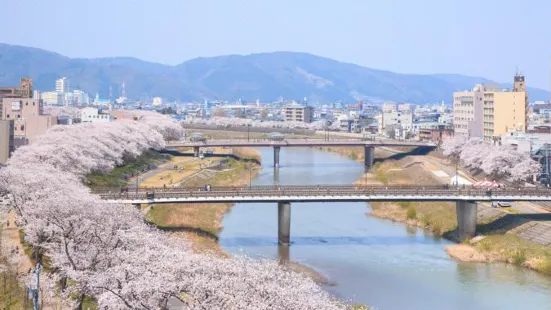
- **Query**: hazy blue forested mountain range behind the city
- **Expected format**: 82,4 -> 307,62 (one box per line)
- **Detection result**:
0,44 -> 549,103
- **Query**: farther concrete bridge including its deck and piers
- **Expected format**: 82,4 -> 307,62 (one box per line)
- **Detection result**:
166,139 -> 436,168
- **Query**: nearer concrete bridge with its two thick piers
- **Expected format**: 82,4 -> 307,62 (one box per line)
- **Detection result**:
93,185 -> 551,245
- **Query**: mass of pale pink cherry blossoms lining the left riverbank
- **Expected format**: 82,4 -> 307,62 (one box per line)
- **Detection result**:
0,112 -> 347,309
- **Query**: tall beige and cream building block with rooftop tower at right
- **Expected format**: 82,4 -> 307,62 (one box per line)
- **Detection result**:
453,74 -> 528,140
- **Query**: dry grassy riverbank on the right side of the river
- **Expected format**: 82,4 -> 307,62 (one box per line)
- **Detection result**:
326,148 -> 551,275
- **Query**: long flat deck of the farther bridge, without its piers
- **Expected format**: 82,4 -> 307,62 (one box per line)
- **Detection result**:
166,139 -> 436,147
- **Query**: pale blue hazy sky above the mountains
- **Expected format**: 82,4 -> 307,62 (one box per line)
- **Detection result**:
0,0 -> 551,89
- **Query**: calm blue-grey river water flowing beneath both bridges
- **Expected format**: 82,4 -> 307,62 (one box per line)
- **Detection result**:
220,148 -> 551,310
